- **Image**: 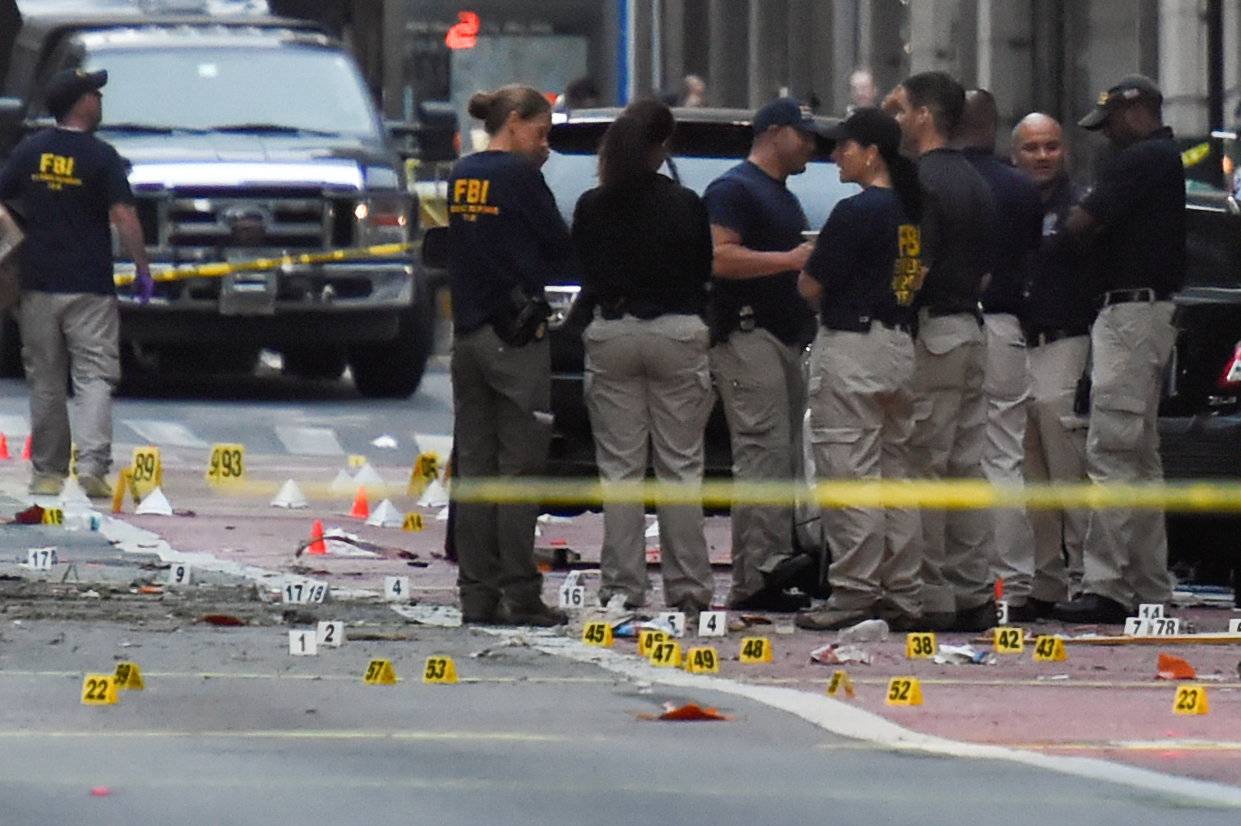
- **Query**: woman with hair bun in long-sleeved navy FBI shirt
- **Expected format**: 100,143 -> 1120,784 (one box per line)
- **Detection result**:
448,86 -> 571,625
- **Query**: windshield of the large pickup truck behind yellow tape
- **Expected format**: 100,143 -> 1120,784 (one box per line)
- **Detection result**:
86,46 -> 380,140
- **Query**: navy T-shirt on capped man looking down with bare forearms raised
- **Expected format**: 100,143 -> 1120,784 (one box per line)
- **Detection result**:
702,160 -> 814,344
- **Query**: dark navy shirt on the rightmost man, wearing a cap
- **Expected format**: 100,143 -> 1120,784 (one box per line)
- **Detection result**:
1082,127 -> 1185,294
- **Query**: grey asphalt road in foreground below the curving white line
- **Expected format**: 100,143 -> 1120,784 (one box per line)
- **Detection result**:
0,621 -> 1236,826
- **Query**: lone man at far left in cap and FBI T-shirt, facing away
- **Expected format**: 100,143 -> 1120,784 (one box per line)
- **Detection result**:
0,69 -> 154,499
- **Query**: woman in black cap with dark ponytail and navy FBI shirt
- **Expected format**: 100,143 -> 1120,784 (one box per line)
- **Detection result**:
797,108 -> 925,630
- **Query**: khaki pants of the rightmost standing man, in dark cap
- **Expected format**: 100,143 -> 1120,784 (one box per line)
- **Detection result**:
1082,301 -> 1176,608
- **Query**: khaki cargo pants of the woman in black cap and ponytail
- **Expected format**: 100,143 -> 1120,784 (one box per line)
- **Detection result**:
808,321 -> 922,616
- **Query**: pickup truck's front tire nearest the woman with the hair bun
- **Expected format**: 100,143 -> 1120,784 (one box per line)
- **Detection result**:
349,289 -> 436,398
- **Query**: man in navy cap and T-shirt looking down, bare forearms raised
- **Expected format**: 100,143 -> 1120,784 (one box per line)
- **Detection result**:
702,98 -> 817,611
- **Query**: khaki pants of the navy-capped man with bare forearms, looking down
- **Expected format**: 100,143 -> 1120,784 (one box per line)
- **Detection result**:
710,327 -> 805,604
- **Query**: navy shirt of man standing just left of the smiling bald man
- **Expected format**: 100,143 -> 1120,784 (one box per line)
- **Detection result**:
964,149 -> 1042,315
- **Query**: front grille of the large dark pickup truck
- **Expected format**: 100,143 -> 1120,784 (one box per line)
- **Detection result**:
138,190 -> 356,250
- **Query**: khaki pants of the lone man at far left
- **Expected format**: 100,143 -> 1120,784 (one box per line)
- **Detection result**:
20,290 -> 120,479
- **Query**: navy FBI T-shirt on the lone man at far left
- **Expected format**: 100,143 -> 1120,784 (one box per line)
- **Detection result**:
0,128 -> 134,295
